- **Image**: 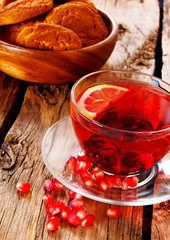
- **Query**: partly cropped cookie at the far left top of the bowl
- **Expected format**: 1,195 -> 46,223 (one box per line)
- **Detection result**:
0,0 -> 54,26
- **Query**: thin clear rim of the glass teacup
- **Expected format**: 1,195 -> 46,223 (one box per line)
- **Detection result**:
71,70 -> 170,138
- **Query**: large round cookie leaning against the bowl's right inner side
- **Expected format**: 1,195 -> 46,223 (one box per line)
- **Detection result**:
45,2 -> 108,47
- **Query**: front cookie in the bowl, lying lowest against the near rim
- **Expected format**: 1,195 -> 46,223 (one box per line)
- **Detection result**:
16,23 -> 82,50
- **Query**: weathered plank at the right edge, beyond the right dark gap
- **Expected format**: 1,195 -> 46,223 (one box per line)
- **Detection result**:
151,0 -> 170,240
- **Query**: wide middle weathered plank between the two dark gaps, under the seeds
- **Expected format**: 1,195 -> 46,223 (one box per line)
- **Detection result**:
0,0 -> 159,240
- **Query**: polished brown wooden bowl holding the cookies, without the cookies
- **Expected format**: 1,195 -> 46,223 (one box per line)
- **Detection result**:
0,10 -> 118,84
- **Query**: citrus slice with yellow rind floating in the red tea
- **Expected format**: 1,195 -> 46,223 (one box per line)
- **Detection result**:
78,84 -> 128,118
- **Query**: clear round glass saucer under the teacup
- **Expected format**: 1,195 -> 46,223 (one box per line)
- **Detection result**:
41,116 -> 170,206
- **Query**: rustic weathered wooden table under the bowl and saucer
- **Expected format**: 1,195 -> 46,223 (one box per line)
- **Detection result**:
0,0 -> 170,240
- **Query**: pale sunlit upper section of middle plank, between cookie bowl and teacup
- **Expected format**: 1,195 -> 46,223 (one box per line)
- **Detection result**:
93,0 -> 159,74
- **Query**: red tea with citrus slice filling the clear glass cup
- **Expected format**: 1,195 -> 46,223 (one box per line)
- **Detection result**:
71,80 -> 170,175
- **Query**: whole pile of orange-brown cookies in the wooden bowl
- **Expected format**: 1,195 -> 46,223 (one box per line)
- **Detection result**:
0,0 -> 108,50
